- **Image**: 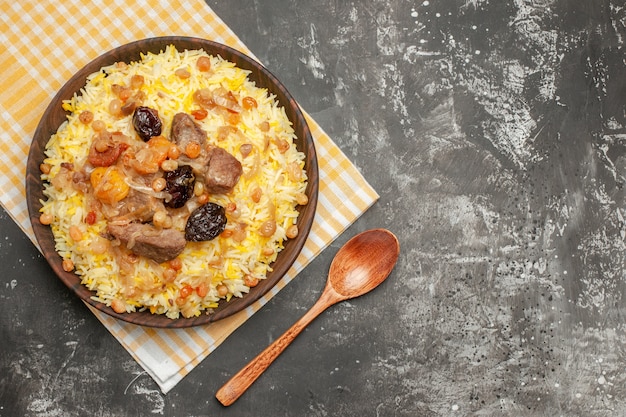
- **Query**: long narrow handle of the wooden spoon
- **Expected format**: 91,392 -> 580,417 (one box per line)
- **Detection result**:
215,287 -> 343,406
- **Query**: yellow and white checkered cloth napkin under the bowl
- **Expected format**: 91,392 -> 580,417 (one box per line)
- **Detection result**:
0,0 -> 378,392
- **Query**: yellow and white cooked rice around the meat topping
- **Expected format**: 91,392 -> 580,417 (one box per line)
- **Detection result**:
41,46 -> 307,319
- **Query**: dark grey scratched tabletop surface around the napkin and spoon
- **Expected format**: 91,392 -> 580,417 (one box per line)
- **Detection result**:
0,0 -> 626,417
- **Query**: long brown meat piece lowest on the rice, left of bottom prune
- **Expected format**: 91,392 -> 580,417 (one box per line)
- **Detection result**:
107,223 -> 187,263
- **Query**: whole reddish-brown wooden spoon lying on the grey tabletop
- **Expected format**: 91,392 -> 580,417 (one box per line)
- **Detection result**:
215,229 -> 400,406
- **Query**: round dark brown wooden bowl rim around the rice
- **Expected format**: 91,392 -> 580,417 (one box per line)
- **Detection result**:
26,36 -> 319,328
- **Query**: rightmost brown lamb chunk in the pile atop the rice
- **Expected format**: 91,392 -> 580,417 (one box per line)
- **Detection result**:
204,147 -> 243,194
